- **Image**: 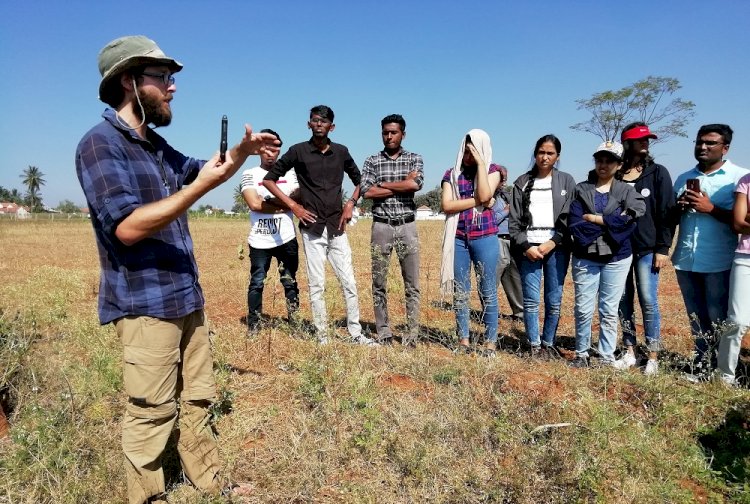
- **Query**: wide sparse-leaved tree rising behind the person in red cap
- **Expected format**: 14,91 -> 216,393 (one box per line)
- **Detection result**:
570,76 -> 695,142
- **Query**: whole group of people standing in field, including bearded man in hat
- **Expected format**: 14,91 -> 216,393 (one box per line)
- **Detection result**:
75,36 -> 750,504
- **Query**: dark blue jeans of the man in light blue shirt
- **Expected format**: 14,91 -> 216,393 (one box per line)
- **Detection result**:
676,269 -> 732,360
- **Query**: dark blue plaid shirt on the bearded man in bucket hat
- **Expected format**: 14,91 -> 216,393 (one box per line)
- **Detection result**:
75,109 -> 204,324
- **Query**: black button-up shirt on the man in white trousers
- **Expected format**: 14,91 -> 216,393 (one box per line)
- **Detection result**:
264,139 -> 362,237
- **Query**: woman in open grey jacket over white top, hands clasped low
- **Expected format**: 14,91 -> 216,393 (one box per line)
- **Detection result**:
509,135 -> 576,359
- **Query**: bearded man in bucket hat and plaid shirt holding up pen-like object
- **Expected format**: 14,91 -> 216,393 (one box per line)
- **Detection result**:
75,36 -> 278,503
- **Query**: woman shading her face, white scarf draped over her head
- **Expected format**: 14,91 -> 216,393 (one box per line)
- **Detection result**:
440,129 -> 500,357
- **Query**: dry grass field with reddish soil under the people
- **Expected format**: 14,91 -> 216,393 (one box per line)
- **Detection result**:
0,218 -> 750,503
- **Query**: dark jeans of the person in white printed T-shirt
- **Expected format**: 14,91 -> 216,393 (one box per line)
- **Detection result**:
247,238 -> 299,327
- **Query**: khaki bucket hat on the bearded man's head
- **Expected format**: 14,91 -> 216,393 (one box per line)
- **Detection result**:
98,35 -> 182,103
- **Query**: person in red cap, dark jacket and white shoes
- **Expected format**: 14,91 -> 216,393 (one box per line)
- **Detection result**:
615,122 -> 675,375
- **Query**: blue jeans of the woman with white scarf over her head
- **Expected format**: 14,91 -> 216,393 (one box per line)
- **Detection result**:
453,235 -> 500,343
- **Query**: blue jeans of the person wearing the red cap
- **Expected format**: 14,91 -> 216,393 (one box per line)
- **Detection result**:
620,253 -> 661,352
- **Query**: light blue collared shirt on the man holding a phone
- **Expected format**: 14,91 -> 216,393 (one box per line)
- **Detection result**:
672,159 -> 748,273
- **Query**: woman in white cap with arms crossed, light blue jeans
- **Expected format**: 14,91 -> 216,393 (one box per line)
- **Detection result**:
568,142 -> 646,367
